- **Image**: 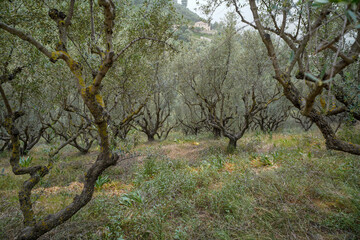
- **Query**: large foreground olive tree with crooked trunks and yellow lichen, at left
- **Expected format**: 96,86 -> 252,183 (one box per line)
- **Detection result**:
0,0 -> 177,239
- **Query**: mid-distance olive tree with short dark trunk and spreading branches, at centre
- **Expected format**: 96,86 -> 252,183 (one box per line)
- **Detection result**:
181,15 -> 280,152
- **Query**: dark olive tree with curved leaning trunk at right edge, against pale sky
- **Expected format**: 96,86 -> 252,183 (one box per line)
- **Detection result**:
208,0 -> 360,155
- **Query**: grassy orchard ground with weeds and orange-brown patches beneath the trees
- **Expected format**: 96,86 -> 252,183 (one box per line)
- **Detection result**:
0,129 -> 360,239
